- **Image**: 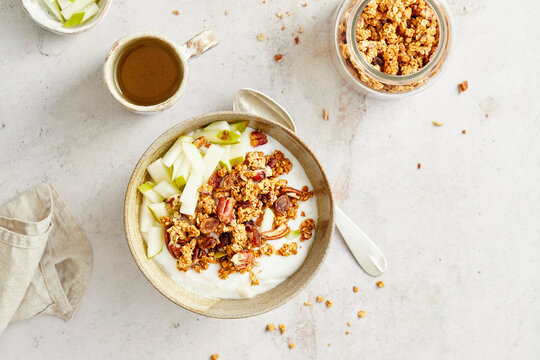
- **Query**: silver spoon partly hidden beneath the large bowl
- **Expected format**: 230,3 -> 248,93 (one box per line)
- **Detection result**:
233,89 -> 386,276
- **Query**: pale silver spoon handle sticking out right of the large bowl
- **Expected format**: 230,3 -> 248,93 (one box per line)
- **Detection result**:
335,206 -> 386,276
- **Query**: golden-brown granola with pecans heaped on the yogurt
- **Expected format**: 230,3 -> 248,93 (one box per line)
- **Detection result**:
161,131 -> 315,285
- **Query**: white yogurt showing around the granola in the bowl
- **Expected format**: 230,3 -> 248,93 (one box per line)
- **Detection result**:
150,128 -> 317,299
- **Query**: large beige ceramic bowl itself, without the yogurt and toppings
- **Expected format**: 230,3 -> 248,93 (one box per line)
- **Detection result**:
124,112 -> 334,318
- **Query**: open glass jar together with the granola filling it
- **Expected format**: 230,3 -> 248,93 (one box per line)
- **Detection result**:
332,0 -> 454,99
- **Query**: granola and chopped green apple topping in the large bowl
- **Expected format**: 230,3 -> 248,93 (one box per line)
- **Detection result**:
140,122 -> 316,298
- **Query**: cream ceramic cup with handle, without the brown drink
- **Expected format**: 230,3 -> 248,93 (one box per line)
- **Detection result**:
103,30 -> 219,114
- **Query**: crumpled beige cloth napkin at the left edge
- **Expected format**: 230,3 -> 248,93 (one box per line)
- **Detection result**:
0,183 -> 92,334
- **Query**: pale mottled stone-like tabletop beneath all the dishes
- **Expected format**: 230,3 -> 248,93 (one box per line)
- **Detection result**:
0,0 -> 540,359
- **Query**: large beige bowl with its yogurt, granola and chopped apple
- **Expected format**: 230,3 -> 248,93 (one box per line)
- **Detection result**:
124,112 -> 333,318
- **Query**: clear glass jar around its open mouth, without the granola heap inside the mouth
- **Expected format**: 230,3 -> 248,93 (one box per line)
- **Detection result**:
331,0 -> 454,99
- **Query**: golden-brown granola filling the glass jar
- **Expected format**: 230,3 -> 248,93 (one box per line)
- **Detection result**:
338,0 -> 440,93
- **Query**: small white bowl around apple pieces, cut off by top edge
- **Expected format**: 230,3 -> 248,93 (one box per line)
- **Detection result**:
21,0 -> 112,35
